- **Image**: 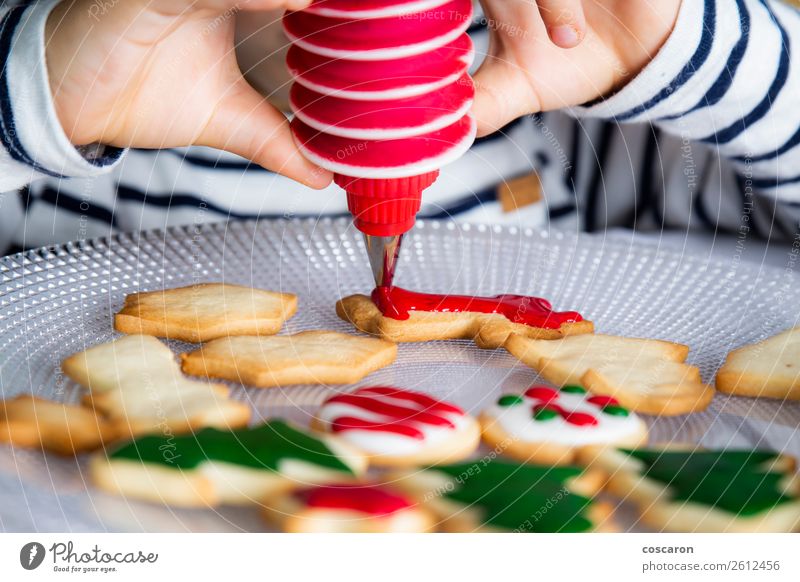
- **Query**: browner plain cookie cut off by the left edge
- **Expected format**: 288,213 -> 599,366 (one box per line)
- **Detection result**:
0,394 -> 116,455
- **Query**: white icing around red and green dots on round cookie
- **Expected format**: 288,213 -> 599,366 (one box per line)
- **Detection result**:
486,392 -> 641,446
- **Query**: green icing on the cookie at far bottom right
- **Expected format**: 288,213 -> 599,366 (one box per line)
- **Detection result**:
623,449 -> 797,516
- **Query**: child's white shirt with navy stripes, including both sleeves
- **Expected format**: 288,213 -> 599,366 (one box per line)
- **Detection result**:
0,0 -> 800,252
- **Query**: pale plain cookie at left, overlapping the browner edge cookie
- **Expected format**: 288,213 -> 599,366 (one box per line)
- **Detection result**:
61,335 -> 251,435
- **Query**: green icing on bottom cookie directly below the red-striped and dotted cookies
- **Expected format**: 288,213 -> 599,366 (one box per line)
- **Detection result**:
429,459 -> 593,533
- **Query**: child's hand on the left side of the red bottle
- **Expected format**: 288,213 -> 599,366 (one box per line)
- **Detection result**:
47,0 -> 331,188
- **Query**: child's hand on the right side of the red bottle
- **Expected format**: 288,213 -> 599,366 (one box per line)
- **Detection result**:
473,0 -> 681,135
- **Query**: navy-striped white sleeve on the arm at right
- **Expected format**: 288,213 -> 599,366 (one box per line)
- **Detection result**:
574,0 -> 800,202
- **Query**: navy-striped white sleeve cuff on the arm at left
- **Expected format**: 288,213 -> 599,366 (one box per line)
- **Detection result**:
0,0 -> 122,192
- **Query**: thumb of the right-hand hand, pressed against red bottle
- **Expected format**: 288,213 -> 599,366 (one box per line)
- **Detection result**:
472,56 -> 539,137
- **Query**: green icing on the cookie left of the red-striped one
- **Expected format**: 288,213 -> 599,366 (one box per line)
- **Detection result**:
109,420 -> 353,474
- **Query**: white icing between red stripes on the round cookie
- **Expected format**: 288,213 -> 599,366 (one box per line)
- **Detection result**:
317,392 -> 467,455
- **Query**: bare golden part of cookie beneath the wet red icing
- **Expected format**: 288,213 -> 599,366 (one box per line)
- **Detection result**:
336,295 -> 594,348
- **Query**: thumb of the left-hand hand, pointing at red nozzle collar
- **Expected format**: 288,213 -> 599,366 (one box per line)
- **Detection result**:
197,80 -> 333,188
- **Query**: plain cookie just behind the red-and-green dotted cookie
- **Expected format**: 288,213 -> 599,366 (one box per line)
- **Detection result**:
505,334 -> 714,416
